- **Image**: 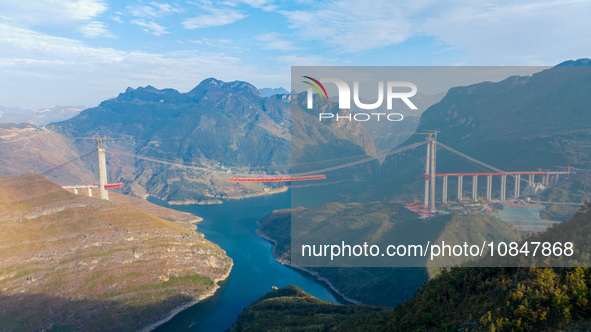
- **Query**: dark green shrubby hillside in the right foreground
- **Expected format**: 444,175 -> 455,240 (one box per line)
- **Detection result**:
233,204 -> 591,331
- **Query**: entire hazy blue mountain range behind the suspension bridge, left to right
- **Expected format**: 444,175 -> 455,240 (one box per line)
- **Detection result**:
0,59 -> 591,202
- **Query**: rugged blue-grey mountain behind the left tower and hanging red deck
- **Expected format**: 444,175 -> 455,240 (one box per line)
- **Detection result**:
42,78 -> 375,203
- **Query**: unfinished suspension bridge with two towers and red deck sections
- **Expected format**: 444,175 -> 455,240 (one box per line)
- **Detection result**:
41,132 -> 572,216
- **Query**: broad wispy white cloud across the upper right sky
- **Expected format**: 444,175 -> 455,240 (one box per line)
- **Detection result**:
280,0 -> 591,64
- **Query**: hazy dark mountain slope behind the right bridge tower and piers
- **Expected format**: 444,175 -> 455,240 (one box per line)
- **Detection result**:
374,59 -> 591,206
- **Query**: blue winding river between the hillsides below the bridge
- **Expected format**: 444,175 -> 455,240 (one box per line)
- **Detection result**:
149,191 -> 339,332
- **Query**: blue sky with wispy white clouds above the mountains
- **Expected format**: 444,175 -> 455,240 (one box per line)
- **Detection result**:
0,0 -> 591,108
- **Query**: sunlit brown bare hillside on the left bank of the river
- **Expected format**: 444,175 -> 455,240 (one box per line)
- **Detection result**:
0,175 -> 232,331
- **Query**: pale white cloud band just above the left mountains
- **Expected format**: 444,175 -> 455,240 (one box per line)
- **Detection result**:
0,22 -> 285,108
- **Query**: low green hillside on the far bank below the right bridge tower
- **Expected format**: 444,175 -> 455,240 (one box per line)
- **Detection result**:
258,203 -> 519,306
